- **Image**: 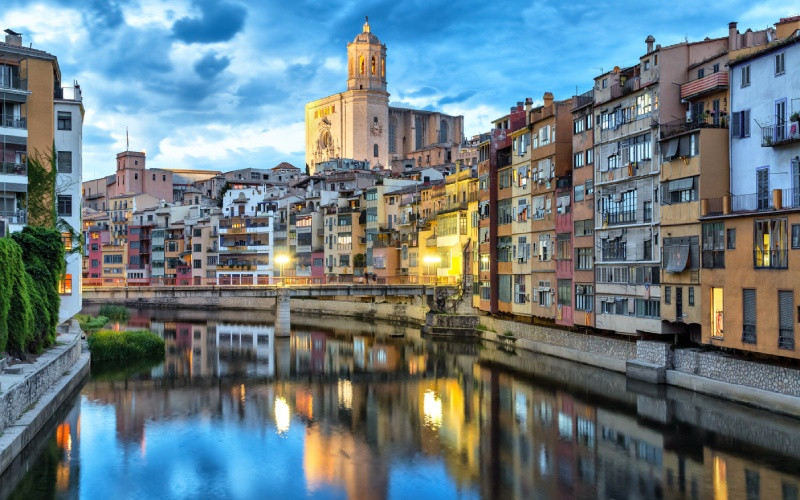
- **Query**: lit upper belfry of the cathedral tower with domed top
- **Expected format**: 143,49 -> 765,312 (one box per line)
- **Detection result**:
347,18 -> 386,92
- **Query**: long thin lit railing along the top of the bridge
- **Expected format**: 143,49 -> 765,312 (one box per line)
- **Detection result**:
82,275 -> 461,288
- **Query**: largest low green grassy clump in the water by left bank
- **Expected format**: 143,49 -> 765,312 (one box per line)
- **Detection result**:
88,330 -> 164,363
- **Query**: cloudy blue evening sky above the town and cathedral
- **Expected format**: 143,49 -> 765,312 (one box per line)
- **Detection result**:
0,0 -> 800,179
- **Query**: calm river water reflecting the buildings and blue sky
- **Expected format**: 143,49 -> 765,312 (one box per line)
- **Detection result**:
0,310 -> 800,500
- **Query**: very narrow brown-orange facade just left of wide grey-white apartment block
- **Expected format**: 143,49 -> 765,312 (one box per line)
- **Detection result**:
571,90 -> 595,327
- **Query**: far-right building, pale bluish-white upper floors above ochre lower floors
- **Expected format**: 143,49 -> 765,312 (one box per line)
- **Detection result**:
699,24 -> 800,359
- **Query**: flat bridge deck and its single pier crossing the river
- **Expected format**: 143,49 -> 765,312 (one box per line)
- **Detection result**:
82,283 -> 459,336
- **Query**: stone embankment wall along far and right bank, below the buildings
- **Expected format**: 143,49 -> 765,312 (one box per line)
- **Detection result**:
84,293 -> 800,417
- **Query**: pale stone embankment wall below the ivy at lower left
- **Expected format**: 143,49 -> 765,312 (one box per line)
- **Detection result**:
0,321 -> 89,473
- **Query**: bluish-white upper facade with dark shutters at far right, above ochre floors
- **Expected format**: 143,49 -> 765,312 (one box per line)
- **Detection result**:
730,33 -> 800,206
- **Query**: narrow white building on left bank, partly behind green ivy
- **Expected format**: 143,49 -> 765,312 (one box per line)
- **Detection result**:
53,85 -> 84,322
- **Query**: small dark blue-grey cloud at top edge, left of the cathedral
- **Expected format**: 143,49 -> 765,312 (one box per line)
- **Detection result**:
172,0 -> 247,43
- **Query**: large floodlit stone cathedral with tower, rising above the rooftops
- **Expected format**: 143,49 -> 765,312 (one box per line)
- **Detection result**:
305,19 -> 464,174
